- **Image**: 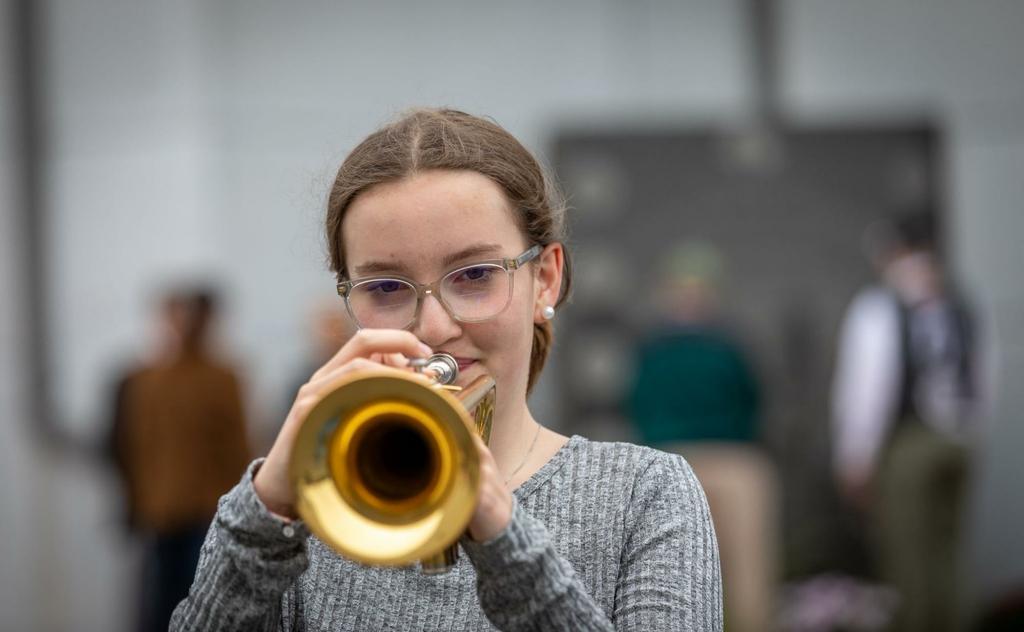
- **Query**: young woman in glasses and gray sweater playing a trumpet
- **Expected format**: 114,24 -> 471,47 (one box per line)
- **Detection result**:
171,110 -> 722,631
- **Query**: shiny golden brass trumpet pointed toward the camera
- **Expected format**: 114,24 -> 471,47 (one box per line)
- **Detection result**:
289,353 -> 496,575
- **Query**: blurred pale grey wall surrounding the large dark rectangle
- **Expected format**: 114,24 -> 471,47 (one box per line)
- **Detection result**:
0,0 -> 1024,631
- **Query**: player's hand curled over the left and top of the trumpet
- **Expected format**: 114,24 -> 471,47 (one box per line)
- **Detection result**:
253,329 -> 431,519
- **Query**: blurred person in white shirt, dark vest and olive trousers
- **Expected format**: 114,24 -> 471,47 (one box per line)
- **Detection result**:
833,211 -> 980,632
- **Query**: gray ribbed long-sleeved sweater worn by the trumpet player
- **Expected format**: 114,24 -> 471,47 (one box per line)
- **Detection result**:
171,436 -> 722,632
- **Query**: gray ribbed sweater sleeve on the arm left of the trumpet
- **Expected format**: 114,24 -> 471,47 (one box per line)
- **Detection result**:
170,459 -> 309,631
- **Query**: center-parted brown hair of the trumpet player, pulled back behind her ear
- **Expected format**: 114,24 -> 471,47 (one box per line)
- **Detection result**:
327,109 -> 572,392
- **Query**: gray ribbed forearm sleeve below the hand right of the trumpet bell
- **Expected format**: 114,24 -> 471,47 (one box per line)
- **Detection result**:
462,501 -> 615,632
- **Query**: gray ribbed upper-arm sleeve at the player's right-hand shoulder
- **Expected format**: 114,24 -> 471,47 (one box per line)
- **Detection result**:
614,453 -> 723,632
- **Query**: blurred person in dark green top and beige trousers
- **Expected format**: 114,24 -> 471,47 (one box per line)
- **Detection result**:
629,242 -> 777,632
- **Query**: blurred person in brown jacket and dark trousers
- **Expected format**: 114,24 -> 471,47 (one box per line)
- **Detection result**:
111,290 -> 251,631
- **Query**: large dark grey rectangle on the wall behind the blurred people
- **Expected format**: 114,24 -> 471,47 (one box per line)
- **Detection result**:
554,124 -> 942,577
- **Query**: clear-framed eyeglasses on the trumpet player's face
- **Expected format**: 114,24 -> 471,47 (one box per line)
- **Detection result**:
338,245 -> 542,329
